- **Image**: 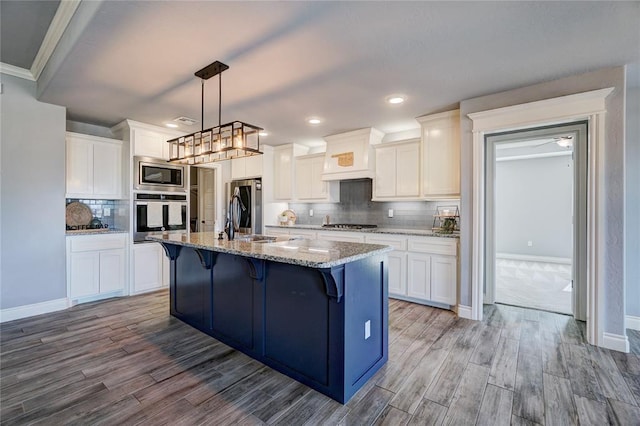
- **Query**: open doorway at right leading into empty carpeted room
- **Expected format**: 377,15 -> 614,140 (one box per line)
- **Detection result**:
484,122 -> 588,321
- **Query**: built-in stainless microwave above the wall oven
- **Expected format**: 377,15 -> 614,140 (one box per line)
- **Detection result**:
133,157 -> 187,192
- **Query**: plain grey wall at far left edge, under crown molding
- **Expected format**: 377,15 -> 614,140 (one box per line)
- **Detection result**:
0,74 -> 67,309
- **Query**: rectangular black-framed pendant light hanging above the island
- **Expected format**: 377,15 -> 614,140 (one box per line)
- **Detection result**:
167,61 -> 264,164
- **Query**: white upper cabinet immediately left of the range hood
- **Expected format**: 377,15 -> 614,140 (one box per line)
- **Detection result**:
295,153 -> 340,203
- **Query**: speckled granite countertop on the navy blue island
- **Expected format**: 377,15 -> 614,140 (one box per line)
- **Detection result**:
146,232 -> 393,268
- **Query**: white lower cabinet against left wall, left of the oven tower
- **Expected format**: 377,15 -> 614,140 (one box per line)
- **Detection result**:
67,234 -> 126,301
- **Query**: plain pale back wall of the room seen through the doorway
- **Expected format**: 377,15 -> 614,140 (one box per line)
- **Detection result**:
495,155 -> 573,259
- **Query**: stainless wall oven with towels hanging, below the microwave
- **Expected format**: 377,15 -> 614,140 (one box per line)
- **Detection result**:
133,192 -> 188,243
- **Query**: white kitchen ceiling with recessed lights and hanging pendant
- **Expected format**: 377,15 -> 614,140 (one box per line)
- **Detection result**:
2,0 -> 640,145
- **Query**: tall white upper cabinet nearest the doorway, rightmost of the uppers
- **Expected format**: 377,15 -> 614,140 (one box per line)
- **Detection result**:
416,110 -> 460,200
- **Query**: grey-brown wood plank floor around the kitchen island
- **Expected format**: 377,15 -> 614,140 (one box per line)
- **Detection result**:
0,291 -> 640,425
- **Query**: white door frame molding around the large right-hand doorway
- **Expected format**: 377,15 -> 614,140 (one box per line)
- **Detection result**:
468,87 -> 614,346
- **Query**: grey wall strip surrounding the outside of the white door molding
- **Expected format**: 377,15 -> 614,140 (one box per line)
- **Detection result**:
460,67 -> 624,335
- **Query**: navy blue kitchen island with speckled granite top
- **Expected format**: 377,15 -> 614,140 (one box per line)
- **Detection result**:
147,232 -> 391,403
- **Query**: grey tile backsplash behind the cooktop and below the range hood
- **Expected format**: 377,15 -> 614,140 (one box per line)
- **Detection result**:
289,179 -> 460,229
